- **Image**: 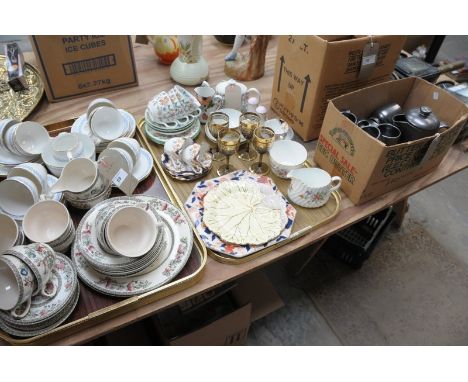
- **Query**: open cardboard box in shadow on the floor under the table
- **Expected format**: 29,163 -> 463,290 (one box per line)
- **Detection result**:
153,272 -> 284,346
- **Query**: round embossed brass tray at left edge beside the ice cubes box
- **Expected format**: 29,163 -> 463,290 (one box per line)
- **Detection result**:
0,55 -> 44,121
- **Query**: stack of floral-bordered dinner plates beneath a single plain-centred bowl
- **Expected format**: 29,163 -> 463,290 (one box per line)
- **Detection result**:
72,195 -> 193,297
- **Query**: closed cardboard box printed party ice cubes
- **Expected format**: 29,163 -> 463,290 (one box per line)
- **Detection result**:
31,35 -> 138,102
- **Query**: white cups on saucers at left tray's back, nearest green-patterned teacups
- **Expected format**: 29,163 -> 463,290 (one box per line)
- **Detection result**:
71,98 -> 136,153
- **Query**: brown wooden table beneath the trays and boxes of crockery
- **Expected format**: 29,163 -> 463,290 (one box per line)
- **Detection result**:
7,36 -> 468,345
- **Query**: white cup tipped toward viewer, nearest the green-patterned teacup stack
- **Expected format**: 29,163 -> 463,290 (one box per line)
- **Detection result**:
89,106 -> 127,141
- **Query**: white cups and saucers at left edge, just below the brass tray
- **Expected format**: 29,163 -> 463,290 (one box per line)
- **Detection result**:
0,119 -> 49,177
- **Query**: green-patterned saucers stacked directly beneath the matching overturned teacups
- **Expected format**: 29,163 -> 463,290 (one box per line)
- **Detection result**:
145,109 -> 201,145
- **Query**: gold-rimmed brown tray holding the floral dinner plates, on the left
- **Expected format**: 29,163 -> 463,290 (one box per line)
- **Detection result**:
0,119 -> 207,345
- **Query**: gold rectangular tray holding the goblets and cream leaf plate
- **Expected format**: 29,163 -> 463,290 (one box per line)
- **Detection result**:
137,119 -> 341,264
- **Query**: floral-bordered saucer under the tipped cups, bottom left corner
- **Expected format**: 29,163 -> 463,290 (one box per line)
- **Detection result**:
0,253 -> 78,328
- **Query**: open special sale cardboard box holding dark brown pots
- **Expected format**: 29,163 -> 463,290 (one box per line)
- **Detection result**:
314,77 -> 468,204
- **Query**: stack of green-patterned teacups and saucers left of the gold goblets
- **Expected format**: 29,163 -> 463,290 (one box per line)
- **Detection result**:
145,85 -> 201,145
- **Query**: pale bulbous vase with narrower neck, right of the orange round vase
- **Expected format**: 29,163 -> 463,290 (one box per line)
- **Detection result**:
171,36 -> 208,86
